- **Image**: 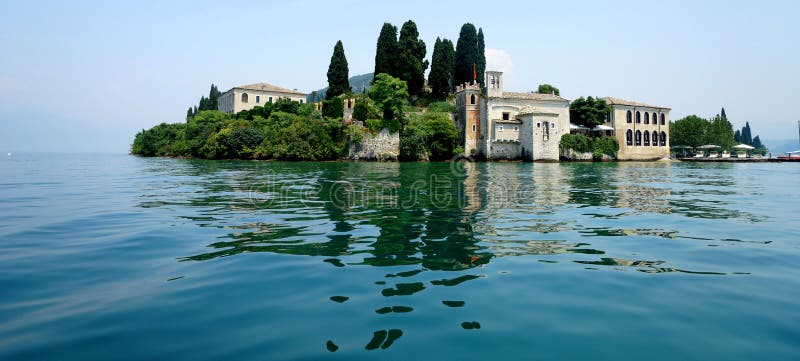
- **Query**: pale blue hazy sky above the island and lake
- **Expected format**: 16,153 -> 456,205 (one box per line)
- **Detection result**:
0,0 -> 800,152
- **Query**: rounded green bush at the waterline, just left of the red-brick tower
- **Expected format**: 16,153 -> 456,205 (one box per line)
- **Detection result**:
400,111 -> 459,160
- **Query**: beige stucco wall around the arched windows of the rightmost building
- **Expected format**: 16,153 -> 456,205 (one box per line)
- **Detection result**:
606,105 -> 670,160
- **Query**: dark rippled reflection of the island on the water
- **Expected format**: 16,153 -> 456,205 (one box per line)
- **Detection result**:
134,161 -> 763,352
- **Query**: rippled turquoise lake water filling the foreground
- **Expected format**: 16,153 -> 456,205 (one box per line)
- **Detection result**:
0,154 -> 800,360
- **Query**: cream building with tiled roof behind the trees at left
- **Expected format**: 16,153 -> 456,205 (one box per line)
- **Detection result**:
217,83 -> 308,114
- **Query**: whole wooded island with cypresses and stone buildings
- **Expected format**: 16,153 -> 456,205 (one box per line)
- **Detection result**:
131,20 -> 767,162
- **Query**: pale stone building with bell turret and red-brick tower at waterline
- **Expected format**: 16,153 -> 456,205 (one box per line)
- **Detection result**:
456,71 -> 570,161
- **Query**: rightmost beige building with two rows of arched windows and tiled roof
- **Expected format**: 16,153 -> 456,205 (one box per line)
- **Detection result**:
603,97 -> 670,160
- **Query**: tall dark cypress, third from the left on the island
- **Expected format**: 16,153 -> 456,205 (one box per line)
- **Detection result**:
395,20 -> 428,96
